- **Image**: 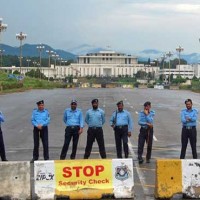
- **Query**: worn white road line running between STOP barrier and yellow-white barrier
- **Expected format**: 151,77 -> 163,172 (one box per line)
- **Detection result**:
128,139 -> 149,199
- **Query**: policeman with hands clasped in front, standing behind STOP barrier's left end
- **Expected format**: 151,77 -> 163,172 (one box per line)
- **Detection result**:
31,100 -> 50,162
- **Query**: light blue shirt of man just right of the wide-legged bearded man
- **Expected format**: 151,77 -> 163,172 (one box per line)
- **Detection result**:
110,110 -> 133,132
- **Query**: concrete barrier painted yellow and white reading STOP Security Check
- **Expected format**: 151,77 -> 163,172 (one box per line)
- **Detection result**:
34,159 -> 134,200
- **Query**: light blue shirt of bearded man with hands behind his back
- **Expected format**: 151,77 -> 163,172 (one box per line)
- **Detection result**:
85,108 -> 105,127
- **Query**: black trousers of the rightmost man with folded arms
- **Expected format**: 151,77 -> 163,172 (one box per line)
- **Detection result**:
180,127 -> 197,159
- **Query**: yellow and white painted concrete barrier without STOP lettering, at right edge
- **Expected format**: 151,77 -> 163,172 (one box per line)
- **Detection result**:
155,160 -> 200,199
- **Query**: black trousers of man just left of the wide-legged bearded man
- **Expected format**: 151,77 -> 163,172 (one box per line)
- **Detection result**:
60,126 -> 80,160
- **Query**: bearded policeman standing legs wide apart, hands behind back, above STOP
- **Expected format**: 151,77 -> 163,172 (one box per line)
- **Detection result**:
84,99 -> 106,159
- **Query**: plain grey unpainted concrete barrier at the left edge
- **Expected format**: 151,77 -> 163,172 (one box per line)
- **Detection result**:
0,161 -> 31,199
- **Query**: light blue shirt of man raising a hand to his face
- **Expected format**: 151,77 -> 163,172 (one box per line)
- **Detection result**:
138,110 -> 155,128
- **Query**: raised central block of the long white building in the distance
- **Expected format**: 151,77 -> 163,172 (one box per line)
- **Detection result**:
71,50 -> 148,77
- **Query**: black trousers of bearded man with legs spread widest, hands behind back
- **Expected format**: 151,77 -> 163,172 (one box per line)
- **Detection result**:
84,127 -> 106,159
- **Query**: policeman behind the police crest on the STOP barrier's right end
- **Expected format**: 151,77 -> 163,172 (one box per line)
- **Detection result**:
110,101 -> 133,158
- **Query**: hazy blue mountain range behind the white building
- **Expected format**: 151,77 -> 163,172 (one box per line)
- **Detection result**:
1,44 -> 200,64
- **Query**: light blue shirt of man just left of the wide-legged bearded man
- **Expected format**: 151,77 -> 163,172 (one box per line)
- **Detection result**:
63,108 -> 84,128
